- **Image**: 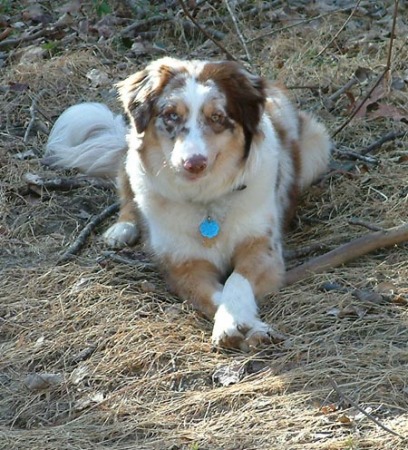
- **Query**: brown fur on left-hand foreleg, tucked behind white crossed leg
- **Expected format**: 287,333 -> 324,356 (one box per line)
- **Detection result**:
163,256 -> 222,319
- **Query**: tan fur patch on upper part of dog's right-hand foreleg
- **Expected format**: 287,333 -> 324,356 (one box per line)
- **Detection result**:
233,236 -> 285,297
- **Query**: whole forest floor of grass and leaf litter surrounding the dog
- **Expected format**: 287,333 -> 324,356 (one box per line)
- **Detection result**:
0,0 -> 408,450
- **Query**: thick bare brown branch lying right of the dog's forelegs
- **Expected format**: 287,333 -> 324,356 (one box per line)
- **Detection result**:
285,223 -> 408,285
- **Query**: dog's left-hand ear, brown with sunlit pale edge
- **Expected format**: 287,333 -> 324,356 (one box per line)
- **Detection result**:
117,58 -> 176,133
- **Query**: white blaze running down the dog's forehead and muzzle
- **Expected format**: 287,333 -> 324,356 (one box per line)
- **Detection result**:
171,78 -> 213,170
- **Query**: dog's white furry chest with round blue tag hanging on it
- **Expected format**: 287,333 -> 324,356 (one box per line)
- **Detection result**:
142,187 -> 272,269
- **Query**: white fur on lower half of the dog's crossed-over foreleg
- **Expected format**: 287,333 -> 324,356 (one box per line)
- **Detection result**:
212,273 -> 269,349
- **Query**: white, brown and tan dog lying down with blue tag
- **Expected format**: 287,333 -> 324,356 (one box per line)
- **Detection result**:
44,57 -> 331,350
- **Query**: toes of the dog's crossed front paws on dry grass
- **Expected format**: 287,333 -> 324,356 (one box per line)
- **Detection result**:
212,305 -> 271,351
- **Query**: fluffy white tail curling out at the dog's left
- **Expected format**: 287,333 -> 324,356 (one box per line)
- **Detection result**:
42,103 -> 127,178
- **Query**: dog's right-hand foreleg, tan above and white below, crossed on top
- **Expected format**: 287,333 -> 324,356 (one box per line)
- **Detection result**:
212,237 -> 284,351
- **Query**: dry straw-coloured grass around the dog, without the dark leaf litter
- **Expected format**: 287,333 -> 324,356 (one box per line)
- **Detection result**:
0,2 -> 408,450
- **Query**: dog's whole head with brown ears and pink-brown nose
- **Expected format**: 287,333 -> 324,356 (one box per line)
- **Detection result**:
119,58 -> 265,190
